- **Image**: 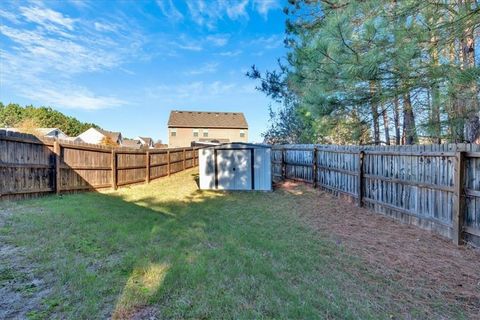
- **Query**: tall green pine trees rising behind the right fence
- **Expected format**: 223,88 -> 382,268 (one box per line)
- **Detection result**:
249,0 -> 480,144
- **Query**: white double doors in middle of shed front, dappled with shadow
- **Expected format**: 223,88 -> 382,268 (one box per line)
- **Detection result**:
217,149 -> 252,190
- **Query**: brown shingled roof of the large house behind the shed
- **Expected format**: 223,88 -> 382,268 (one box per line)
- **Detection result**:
168,110 -> 248,129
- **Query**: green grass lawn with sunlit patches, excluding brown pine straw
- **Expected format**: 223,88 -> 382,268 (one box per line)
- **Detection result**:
0,170 -> 472,319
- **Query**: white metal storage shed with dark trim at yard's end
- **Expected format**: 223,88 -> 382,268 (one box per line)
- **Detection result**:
199,143 -> 272,191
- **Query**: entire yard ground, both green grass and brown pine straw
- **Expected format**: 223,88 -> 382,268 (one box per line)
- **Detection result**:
0,169 -> 480,319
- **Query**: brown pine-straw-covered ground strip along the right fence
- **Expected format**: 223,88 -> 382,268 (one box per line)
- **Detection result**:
276,182 -> 480,319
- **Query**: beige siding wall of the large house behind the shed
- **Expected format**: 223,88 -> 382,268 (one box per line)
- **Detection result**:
168,128 -> 248,148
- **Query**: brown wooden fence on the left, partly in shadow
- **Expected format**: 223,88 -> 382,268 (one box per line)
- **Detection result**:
0,130 -> 198,199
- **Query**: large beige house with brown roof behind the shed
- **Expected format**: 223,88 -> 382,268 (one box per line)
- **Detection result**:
168,110 -> 248,148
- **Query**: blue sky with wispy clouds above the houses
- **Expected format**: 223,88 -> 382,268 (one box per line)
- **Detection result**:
0,0 -> 285,141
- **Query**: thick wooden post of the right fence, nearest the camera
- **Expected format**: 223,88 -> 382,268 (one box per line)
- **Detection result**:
452,151 -> 465,245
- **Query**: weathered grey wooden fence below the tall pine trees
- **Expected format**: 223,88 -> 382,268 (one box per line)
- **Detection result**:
272,144 -> 480,246
